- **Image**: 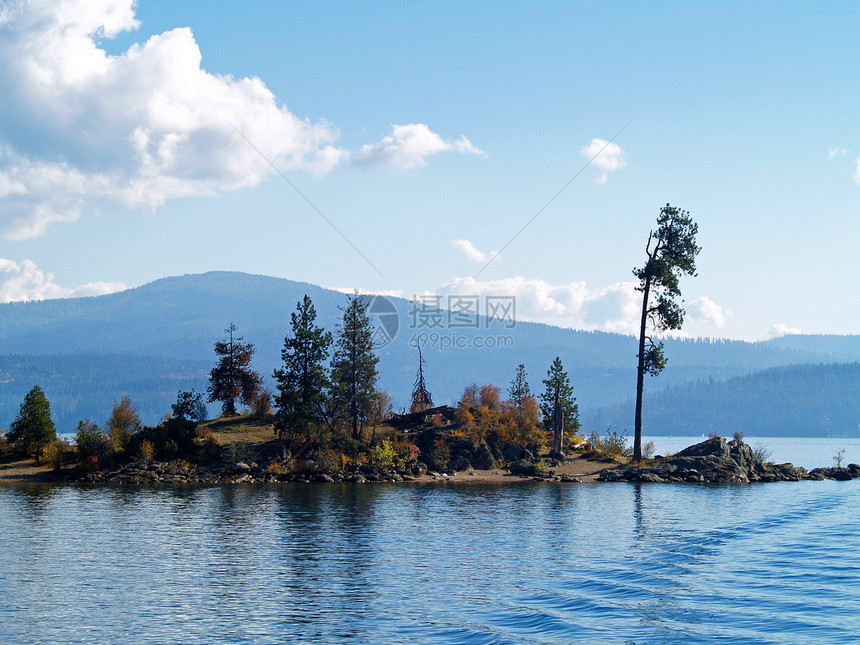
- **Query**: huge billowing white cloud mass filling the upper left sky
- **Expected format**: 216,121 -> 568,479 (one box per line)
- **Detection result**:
0,0 -> 350,239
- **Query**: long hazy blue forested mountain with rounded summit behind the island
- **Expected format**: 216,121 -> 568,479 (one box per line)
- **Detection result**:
0,272 -> 860,431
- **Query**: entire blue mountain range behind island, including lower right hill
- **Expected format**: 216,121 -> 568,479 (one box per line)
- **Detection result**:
0,272 -> 860,435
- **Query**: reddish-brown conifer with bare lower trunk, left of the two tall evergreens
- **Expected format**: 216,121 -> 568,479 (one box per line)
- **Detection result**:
207,322 -> 263,417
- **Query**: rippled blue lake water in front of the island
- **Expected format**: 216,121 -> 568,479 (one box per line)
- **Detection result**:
0,480 -> 860,645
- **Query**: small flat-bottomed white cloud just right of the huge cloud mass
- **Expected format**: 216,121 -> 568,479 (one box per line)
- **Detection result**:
356,123 -> 486,168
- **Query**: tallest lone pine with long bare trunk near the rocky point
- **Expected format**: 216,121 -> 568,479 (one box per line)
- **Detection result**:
633,204 -> 702,461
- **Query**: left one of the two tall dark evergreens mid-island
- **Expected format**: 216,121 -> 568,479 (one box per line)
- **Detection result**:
274,294 -> 332,437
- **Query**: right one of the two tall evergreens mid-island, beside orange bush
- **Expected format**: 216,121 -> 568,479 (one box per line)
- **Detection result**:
331,293 -> 379,439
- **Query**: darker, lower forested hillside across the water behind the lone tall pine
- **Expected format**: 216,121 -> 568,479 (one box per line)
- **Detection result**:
583,363 -> 860,437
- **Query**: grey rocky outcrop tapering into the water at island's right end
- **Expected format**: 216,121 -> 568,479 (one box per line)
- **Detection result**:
598,437 -> 860,484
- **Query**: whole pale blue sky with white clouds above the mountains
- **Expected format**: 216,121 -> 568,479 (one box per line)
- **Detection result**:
0,0 -> 860,339
